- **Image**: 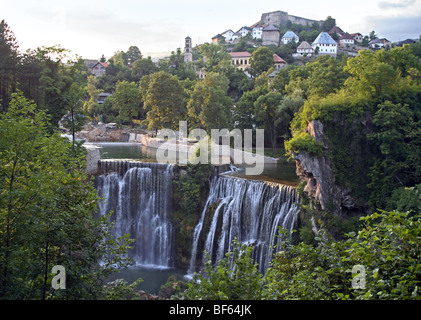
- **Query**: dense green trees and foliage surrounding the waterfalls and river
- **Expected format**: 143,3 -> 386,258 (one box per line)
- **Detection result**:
0,21 -> 421,299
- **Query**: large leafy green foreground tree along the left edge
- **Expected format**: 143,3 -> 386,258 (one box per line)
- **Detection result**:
0,93 -> 135,299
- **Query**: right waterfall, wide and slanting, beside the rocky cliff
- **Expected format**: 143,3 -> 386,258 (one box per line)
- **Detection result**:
189,176 -> 299,274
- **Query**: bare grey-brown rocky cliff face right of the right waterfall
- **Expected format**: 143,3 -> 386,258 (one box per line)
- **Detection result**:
293,120 -> 363,216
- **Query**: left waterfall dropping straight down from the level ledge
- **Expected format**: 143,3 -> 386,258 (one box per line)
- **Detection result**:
95,161 -> 174,267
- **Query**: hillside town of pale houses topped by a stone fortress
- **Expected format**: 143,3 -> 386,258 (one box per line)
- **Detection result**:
85,11 -> 419,79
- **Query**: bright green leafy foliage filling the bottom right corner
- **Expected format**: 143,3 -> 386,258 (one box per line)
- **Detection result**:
265,212 -> 421,300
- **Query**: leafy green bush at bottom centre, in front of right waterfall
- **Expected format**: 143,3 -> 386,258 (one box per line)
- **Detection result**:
183,240 -> 264,300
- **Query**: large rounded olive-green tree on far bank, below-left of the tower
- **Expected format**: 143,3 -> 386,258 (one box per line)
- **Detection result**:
143,71 -> 186,131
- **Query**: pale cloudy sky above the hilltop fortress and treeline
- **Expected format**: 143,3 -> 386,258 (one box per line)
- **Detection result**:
0,0 -> 421,59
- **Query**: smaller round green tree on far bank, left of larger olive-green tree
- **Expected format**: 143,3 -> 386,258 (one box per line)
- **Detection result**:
112,81 -> 142,127
